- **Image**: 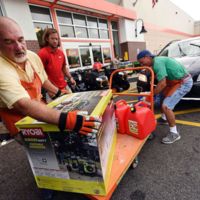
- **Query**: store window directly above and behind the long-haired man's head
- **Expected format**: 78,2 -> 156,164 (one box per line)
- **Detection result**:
29,5 -> 53,47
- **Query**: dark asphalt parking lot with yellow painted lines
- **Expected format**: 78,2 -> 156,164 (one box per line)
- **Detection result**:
0,101 -> 200,200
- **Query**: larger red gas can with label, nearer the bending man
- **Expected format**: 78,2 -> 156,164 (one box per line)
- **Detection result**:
125,101 -> 156,139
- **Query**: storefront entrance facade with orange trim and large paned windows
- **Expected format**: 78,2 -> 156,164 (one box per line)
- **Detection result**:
28,0 -> 136,70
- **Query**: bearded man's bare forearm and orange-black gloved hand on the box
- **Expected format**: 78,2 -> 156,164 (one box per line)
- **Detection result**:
13,98 -> 101,135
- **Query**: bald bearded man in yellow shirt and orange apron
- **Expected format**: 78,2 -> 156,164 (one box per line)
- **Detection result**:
0,17 -> 101,137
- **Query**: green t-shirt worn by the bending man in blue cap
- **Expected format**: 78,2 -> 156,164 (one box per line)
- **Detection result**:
153,56 -> 188,81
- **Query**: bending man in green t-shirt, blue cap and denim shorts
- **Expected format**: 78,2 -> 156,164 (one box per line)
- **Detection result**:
137,50 -> 193,144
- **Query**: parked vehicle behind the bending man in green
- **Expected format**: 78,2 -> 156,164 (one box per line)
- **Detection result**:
158,37 -> 200,100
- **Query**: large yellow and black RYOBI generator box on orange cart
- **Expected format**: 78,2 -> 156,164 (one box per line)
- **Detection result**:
16,90 -> 116,195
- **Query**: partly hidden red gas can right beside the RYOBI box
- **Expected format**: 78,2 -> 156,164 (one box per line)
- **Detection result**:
115,100 -> 130,134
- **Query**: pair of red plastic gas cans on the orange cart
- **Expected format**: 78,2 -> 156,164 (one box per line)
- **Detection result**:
115,100 -> 156,139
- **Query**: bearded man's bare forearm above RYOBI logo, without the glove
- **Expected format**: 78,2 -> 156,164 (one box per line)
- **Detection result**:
13,98 -> 60,125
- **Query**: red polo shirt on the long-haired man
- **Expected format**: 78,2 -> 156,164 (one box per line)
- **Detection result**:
38,47 -> 67,89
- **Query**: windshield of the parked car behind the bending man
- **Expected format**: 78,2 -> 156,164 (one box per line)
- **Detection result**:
168,39 -> 200,57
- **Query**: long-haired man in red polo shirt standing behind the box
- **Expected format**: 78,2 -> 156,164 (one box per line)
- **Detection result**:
38,28 -> 76,96
